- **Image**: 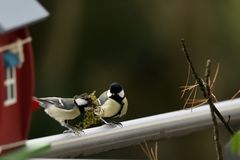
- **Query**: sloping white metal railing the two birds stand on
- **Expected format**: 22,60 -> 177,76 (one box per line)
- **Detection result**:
26,99 -> 240,157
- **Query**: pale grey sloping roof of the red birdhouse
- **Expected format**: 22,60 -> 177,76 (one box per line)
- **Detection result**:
0,0 -> 49,33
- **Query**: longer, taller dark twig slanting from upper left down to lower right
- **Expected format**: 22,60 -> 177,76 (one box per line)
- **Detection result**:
181,39 -> 234,135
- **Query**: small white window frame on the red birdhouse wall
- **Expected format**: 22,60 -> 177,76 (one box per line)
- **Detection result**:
4,67 -> 17,107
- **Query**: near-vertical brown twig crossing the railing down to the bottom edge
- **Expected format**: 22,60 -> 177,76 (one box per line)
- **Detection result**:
205,60 -> 223,160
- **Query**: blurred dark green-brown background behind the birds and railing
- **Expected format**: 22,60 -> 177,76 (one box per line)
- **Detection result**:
30,0 -> 240,160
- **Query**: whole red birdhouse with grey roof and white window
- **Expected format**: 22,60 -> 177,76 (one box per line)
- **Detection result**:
0,0 -> 48,145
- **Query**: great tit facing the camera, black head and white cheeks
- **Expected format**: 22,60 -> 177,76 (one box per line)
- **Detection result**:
96,82 -> 128,125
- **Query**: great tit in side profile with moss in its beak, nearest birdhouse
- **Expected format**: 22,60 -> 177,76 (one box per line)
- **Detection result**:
34,97 -> 88,134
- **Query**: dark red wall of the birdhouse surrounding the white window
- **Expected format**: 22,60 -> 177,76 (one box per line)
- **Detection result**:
0,28 -> 34,144
